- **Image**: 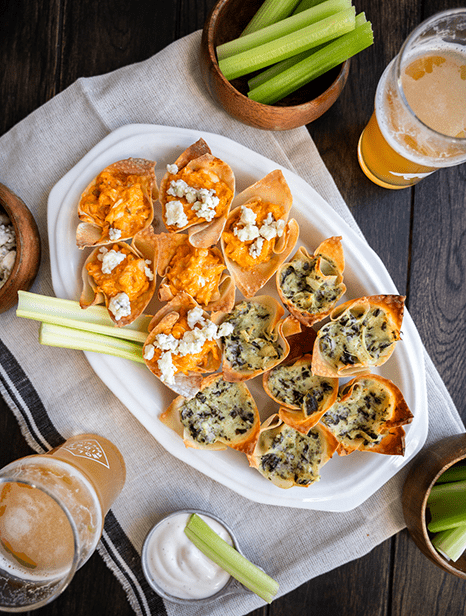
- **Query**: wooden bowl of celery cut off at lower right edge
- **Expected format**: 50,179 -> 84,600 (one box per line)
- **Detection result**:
402,434 -> 466,579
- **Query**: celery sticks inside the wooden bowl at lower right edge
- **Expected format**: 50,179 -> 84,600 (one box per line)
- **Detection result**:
427,463 -> 466,562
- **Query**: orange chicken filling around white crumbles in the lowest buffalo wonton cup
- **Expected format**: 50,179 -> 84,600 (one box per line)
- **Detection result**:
146,313 -> 220,374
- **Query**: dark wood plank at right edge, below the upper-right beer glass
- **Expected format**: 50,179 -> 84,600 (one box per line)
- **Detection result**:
410,165 -> 466,410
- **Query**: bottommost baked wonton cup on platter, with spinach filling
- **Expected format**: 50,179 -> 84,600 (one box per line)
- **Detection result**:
247,415 -> 338,489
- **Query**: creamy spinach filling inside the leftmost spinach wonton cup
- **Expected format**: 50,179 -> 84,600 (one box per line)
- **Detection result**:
180,379 -> 255,444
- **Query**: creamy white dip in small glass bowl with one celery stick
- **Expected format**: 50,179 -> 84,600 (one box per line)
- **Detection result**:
145,512 -> 233,599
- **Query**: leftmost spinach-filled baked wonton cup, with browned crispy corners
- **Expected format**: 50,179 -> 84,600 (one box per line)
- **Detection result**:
160,374 -> 260,454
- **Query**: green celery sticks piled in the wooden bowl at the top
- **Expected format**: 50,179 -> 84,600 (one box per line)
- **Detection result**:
216,0 -> 374,105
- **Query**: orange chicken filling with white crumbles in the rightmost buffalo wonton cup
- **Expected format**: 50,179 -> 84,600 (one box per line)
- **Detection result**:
222,199 -> 285,269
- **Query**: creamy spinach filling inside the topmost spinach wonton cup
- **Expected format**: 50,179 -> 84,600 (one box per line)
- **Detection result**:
280,255 -> 343,314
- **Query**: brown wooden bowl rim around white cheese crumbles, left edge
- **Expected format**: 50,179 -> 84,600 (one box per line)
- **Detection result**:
0,184 -> 41,313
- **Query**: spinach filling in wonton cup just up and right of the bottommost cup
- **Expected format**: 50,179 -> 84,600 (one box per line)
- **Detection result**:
321,379 -> 391,446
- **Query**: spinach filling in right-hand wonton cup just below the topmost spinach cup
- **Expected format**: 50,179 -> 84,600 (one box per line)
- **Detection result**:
319,307 -> 398,366
